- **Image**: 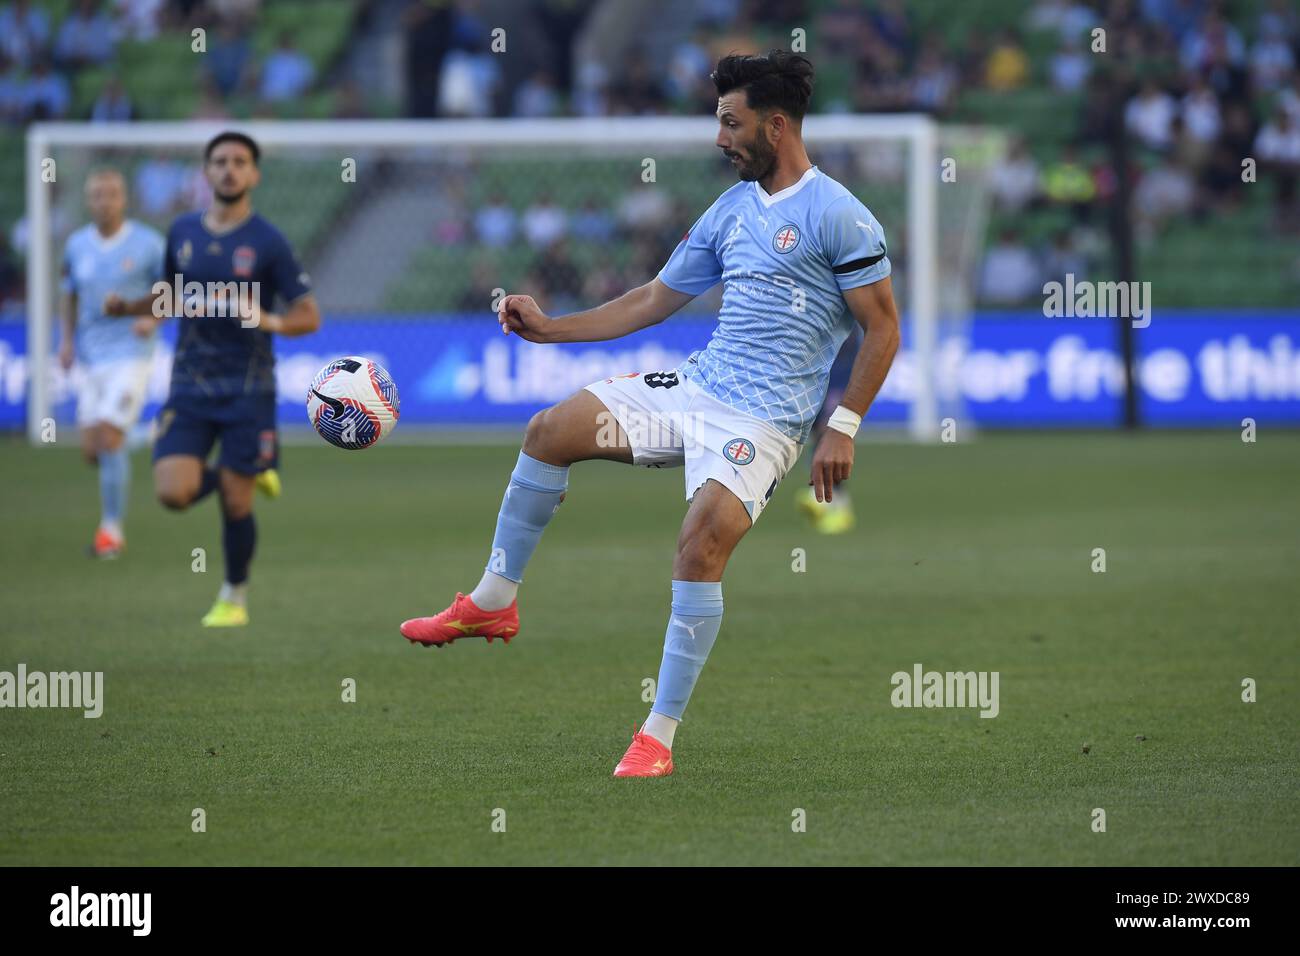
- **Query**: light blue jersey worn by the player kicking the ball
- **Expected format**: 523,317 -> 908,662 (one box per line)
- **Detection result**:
659,166 -> 891,442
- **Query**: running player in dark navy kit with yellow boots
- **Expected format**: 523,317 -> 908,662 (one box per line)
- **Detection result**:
105,133 -> 320,627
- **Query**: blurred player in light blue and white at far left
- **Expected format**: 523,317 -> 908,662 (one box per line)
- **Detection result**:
59,169 -> 164,558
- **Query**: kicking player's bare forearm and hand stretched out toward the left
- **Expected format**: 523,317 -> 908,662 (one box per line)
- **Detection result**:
497,278 -> 696,342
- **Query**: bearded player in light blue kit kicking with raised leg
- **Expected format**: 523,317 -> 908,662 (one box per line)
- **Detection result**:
402,51 -> 898,777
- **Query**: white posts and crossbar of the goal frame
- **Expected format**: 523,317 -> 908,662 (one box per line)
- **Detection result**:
26,114 -> 1001,444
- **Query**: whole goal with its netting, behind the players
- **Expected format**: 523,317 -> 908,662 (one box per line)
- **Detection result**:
25,116 -> 1002,444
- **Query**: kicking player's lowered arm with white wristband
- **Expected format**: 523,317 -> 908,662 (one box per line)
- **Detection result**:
813,277 -> 900,501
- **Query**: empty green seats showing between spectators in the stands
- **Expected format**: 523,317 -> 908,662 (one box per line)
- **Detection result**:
0,0 -> 1300,310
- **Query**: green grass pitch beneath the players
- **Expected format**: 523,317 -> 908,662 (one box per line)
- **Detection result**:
0,429 -> 1300,865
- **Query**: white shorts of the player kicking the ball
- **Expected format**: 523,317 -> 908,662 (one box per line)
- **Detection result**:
586,371 -> 803,523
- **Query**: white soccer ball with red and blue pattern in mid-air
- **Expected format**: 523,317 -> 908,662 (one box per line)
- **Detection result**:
307,355 -> 402,450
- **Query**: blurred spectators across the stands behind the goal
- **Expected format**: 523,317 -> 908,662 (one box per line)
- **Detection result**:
0,0 -> 1300,304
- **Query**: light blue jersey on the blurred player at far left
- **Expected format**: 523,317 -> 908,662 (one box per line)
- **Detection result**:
64,220 -> 165,365
